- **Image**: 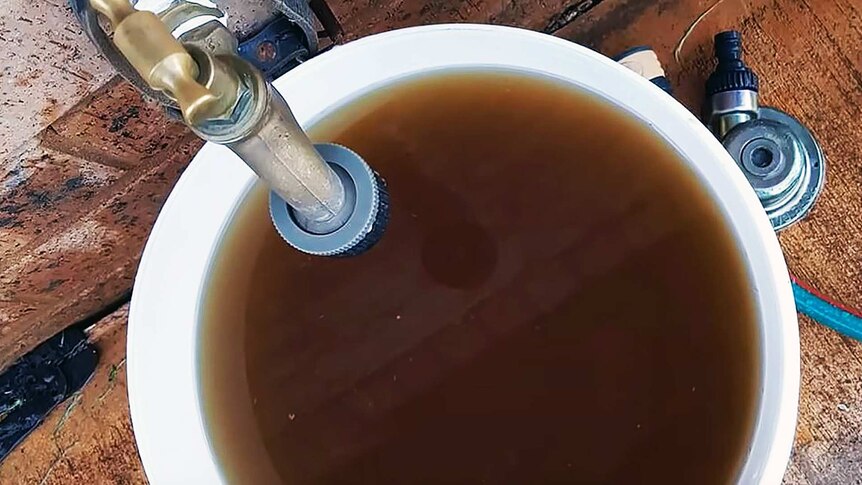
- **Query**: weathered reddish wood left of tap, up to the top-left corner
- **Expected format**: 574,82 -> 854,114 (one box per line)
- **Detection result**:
0,0 -> 200,369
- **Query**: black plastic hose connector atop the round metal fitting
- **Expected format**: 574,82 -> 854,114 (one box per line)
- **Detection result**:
706,30 -> 759,96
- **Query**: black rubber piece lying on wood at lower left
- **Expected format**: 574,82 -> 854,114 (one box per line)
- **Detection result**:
0,327 -> 99,461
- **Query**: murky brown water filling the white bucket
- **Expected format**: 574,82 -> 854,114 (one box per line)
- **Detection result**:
200,72 -> 759,484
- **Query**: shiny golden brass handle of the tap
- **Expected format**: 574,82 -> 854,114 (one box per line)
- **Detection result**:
90,0 -> 236,126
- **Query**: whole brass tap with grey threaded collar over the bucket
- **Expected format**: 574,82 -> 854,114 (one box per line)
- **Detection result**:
89,0 -> 389,256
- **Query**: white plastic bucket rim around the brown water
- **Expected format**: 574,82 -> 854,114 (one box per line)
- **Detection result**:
128,25 -> 799,484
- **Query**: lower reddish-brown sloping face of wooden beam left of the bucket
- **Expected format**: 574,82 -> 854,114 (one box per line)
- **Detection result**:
0,130 -> 201,366
